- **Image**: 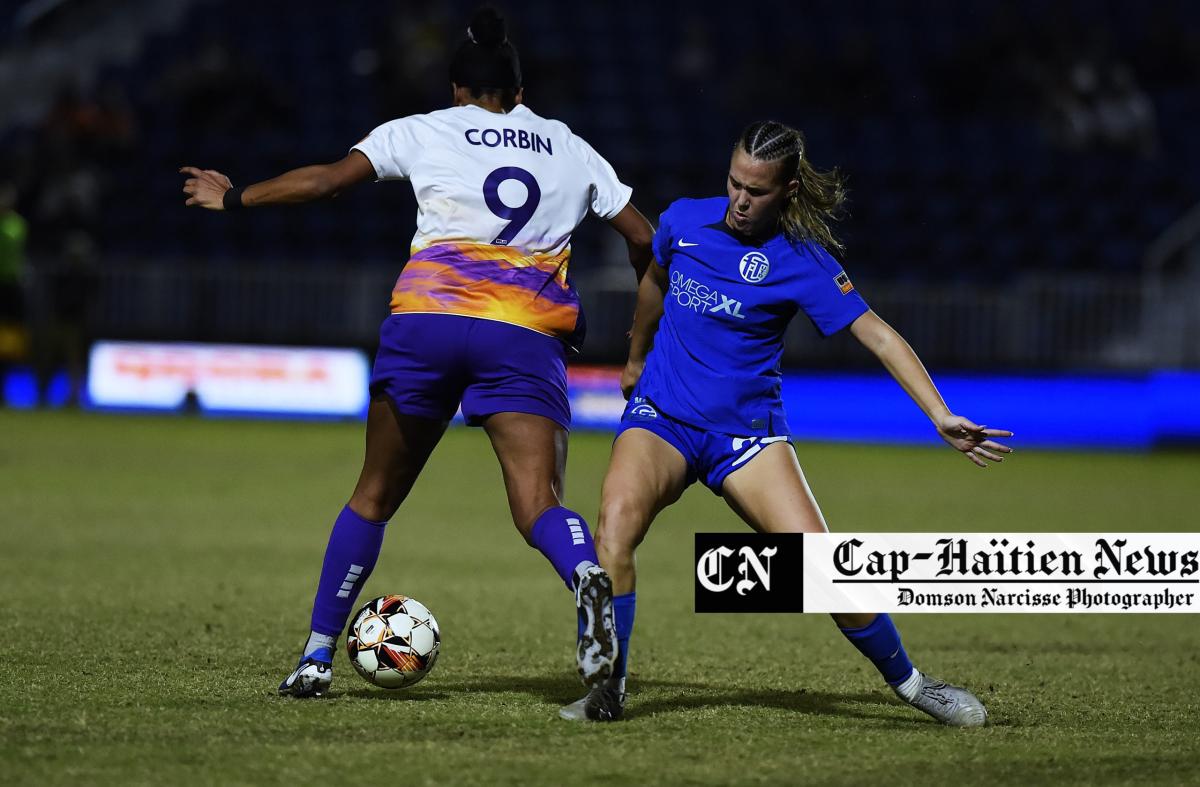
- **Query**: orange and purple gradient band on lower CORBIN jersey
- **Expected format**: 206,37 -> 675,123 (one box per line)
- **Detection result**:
391,242 -> 580,338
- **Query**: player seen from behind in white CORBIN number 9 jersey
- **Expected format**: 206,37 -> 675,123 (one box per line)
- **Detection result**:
181,8 -> 653,697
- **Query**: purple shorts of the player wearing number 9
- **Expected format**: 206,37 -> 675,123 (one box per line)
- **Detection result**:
371,314 -> 571,429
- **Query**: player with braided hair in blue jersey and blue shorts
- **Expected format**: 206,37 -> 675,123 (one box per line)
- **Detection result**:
560,121 -> 1012,727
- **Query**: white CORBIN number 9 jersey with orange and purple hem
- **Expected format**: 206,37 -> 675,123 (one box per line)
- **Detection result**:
354,104 -> 631,338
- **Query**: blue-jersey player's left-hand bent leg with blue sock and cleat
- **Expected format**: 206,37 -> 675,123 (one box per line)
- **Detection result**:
558,428 -> 688,721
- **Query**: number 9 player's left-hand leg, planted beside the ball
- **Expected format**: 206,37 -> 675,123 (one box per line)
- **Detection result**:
280,397 -> 448,697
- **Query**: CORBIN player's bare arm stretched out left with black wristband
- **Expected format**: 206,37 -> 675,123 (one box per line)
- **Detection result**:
179,150 -> 376,210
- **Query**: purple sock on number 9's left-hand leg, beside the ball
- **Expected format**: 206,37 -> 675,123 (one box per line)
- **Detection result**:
312,505 -> 388,637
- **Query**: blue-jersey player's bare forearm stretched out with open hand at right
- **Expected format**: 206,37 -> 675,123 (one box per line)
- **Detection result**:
850,311 -> 1013,467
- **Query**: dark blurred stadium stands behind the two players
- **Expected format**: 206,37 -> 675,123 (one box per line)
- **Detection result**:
0,0 -> 1200,400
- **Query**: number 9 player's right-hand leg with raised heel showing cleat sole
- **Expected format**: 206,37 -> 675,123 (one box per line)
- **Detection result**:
484,413 -> 617,686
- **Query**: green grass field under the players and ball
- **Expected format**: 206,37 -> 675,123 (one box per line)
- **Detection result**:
0,410 -> 1200,786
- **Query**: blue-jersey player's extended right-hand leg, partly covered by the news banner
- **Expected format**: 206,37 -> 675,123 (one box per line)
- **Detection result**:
721,443 -> 988,727
